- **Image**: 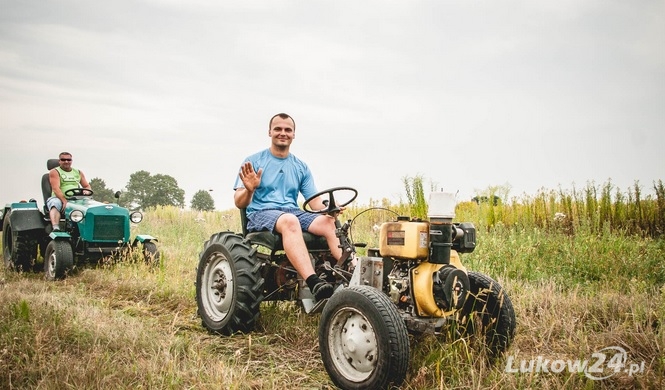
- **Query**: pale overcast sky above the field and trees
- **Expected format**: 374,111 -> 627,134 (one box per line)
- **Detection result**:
0,0 -> 665,210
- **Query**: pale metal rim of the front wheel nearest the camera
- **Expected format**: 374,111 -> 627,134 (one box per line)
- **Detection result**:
328,307 -> 378,382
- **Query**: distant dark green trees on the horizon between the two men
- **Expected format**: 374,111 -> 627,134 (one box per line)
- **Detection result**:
90,171 -> 215,211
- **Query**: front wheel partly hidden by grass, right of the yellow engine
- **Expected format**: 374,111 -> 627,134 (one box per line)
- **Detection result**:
458,271 -> 516,357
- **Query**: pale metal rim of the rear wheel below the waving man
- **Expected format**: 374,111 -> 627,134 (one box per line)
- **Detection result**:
201,253 -> 234,321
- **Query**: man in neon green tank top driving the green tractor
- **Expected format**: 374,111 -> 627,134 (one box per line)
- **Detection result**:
46,152 -> 91,231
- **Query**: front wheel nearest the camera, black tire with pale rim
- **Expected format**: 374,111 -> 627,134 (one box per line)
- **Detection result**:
319,286 -> 409,389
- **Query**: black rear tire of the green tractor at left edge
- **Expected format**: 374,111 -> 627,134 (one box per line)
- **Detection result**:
2,210 -> 38,272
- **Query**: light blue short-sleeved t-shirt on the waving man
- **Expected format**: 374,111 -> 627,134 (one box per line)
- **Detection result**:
233,149 -> 317,215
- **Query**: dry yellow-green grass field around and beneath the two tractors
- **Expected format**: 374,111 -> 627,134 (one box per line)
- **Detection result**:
0,184 -> 665,390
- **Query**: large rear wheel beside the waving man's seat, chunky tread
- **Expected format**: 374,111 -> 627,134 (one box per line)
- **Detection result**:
196,232 -> 264,335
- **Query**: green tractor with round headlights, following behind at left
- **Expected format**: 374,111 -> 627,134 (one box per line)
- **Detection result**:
0,159 -> 160,280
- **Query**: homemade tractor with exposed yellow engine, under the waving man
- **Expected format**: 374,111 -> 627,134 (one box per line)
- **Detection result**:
196,187 -> 515,389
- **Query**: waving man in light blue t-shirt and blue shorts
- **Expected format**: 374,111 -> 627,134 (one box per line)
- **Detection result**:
233,113 -> 342,301
